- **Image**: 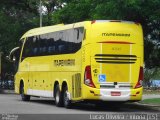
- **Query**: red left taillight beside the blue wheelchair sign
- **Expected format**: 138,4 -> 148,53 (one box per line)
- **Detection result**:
84,66 -> 95,88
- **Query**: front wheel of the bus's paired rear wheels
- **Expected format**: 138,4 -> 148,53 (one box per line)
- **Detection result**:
54,85 -> 63,107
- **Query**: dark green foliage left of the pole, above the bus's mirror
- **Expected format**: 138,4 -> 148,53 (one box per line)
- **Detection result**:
0,0 -> 39,73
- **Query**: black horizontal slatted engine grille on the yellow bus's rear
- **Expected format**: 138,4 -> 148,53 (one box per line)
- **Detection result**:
95,54 -> 137,64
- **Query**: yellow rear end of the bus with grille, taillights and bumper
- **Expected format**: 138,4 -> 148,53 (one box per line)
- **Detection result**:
83,21 -> 143,101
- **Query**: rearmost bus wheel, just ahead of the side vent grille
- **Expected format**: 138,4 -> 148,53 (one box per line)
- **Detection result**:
63,86 -> 71,108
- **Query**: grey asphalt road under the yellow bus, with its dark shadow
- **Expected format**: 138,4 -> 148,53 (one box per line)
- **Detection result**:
0,94 -> 160,114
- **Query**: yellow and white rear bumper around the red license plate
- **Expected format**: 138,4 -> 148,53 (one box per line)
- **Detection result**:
83,86 -> 143,101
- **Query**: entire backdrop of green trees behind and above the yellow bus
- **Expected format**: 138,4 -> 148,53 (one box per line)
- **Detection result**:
0,0 -> 160,75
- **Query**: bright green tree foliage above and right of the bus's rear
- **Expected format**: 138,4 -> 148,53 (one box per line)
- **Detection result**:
53,0 -> 160,68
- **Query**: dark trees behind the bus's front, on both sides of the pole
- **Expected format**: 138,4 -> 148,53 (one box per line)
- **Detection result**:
0,0 -> 63,76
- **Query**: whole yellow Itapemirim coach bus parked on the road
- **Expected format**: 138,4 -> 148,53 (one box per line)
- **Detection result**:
12,20 -> 144,108
